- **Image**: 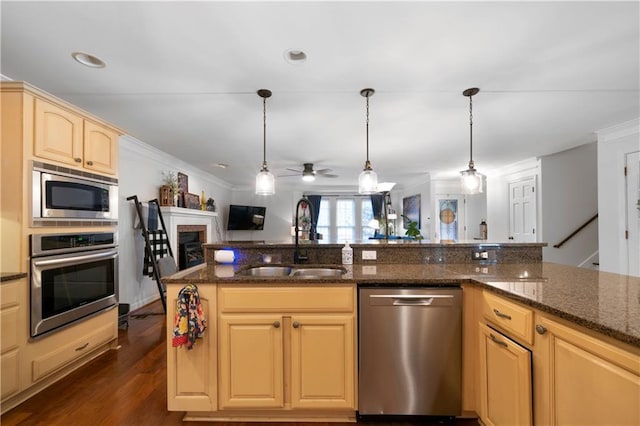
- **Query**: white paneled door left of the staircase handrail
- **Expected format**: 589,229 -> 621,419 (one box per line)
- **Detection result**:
509,176 -> 537,243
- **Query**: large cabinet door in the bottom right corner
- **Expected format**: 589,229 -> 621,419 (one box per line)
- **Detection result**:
536,318 -> 640,425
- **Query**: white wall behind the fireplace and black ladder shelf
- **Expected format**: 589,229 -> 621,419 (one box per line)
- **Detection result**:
118,135 -> 231,309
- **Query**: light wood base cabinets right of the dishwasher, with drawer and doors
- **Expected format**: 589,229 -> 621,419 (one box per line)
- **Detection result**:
464,289 -> 640,426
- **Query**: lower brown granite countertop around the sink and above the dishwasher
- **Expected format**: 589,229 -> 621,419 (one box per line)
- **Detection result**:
166,262 -> 640,347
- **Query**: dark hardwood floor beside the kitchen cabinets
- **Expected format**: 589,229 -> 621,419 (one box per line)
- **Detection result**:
0,302 -> 478,426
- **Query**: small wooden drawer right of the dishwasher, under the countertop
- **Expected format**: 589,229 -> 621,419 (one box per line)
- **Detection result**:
482,291 -> 533,345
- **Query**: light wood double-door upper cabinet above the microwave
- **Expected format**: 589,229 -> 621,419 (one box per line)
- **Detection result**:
34,99 -> 118,175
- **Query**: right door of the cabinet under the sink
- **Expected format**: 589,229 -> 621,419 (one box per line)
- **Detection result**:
291,314 -> 355,409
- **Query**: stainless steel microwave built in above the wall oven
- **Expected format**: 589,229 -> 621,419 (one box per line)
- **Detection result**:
31,161 -> 118,225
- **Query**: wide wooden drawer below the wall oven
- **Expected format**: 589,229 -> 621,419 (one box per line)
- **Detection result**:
32,324 -> 117,382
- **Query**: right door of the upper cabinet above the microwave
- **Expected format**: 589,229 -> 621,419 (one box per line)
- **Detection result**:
84,120 -> 118,175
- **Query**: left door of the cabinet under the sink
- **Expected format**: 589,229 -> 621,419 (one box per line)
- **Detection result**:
218,314 -> 284,409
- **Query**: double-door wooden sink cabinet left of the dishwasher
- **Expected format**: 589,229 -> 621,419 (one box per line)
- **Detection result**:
218,285 -> 356,410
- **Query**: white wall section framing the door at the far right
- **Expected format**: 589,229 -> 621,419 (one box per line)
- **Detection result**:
597,119 -> 640,274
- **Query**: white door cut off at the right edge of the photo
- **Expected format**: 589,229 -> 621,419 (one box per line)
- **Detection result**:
625,151 -> 640,276
